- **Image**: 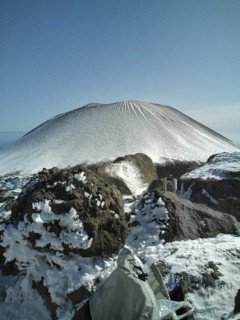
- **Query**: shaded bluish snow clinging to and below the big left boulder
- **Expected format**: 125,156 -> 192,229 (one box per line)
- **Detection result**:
0,192 -> 116,320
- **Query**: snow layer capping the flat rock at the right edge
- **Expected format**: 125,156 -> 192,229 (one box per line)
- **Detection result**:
182,152 -> 240,180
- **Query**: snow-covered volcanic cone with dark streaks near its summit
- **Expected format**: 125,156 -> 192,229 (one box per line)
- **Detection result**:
0,100 -> 239,174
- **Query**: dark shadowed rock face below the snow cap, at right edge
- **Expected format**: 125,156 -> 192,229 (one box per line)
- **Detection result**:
182,179 -> 240,221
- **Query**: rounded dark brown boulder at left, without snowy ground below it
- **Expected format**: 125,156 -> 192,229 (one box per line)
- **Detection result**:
12,166 -> 128,257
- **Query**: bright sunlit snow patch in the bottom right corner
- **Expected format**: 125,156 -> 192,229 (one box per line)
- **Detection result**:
159,235 -> 240,320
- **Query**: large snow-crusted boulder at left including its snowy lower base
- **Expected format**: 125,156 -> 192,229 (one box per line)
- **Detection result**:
0,166 -> 128,319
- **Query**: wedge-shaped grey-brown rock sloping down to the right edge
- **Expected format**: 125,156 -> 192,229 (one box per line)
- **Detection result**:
155,190 -> 240,242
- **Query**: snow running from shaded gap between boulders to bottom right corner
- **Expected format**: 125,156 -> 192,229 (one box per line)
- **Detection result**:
126,195 -> 240,320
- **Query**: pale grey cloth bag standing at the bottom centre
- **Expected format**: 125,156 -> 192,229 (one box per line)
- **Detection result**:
89,248 -> 168,320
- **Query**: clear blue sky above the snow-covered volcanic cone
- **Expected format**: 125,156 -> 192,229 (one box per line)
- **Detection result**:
0,0 -> 240,142
